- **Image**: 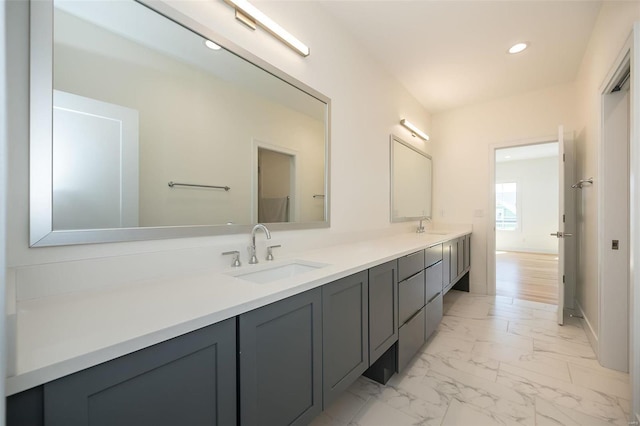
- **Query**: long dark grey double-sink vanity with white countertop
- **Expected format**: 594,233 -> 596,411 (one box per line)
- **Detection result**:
7,229 -> 471,425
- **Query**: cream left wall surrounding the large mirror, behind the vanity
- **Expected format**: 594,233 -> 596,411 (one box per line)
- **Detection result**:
5,1 -> 431,298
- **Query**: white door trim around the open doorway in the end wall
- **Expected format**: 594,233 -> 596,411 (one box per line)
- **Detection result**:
487,134 -> 558,295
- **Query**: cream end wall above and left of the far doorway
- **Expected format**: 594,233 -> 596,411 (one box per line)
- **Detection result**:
432,83 -> 578,293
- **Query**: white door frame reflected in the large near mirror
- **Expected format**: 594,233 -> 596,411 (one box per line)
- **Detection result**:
251,139 -> 300,223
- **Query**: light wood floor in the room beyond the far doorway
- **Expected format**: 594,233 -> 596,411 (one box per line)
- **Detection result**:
496,251 -> 558,305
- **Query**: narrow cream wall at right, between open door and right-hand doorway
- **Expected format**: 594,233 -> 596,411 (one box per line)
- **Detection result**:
576,2 -> 640,346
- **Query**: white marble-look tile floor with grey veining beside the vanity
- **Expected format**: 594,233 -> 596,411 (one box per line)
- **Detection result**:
312,291 -> 630,426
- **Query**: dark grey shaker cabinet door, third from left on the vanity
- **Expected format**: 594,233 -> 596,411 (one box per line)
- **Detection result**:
322,271 -> 369,407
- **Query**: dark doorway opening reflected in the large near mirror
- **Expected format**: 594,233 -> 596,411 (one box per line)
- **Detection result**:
258,147 -> 295,223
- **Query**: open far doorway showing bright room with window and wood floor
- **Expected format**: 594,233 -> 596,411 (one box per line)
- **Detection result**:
494,145 -> 559,305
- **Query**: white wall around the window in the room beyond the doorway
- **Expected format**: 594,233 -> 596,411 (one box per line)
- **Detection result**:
495,156 -> 558,254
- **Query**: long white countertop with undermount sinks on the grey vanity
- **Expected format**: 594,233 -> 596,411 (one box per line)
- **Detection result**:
6,227 -> 471,395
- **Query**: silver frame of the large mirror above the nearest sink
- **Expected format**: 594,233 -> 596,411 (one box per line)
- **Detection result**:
29,0 -> 331,247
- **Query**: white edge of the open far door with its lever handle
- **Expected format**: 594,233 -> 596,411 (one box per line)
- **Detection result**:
551,126 -> 573,325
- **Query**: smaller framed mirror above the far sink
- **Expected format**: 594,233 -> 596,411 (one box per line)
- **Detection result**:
390,135 -> 433,222
